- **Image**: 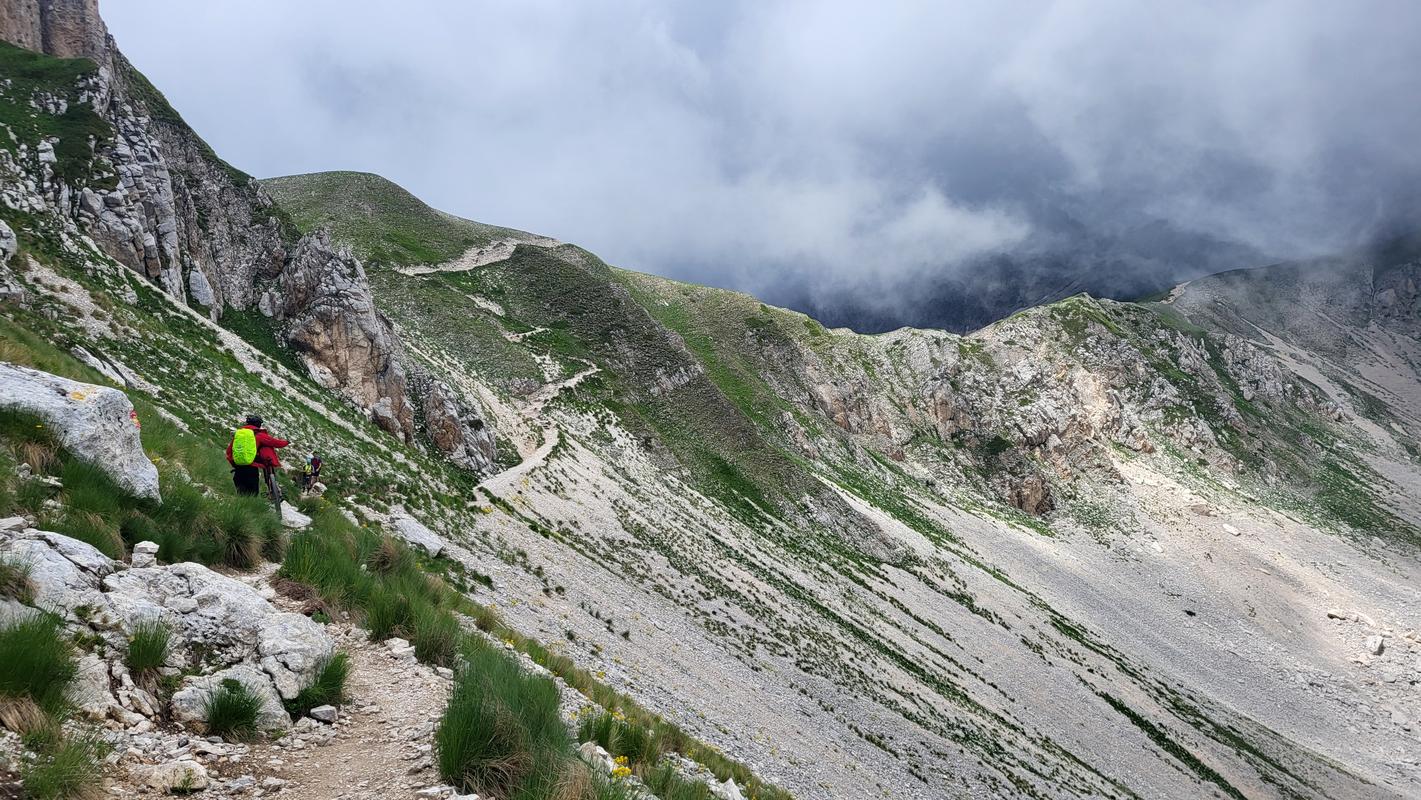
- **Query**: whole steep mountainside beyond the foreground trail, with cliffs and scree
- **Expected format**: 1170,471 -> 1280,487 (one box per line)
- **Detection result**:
0,0 -> 1421,799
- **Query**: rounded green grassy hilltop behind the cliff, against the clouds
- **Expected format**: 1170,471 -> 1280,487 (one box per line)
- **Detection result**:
260,172 -> 526,266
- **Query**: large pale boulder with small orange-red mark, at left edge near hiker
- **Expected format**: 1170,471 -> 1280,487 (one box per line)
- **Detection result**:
0,364 -> 159,500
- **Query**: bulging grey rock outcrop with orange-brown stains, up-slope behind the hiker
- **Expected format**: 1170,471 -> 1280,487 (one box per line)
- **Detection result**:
261,232 -> 415,442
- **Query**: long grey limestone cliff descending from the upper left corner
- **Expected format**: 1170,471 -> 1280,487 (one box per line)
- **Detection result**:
0,0 -> 493,469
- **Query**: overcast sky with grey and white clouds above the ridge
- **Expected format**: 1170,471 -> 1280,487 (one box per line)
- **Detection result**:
102,0 -> 1421,322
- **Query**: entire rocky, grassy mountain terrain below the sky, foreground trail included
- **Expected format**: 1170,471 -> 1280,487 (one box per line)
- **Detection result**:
0,0 -> 1421,800
